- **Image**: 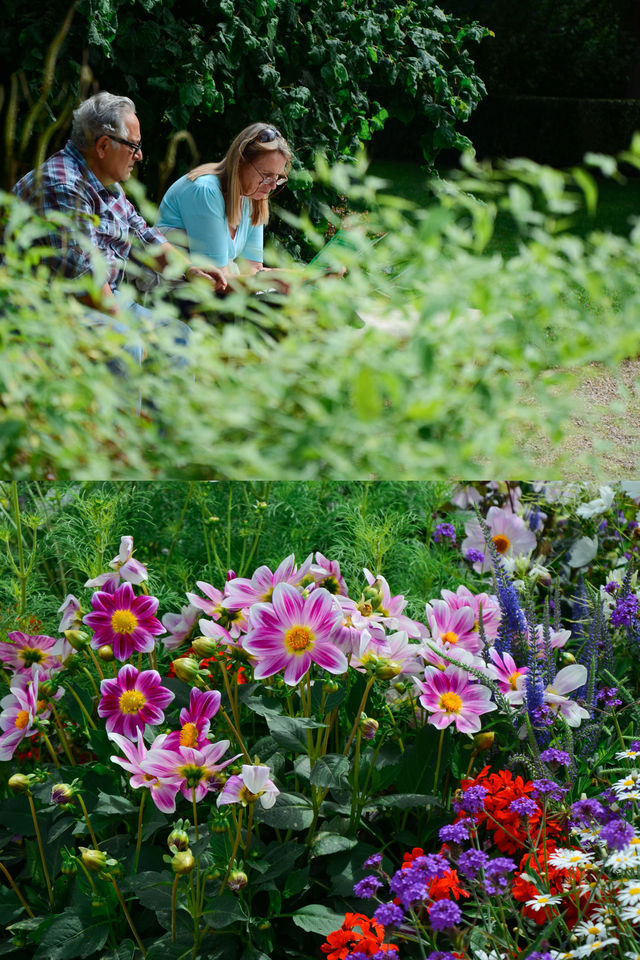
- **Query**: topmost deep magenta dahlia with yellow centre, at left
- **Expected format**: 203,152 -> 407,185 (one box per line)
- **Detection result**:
83,583 -> 165,661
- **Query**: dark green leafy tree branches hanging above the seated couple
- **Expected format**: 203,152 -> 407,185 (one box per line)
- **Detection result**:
0,0 -> 487,190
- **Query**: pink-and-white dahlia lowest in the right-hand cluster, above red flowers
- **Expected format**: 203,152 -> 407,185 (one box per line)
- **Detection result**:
414,667 -> 497,733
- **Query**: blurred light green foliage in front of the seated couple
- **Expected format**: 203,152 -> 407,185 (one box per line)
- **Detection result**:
0,144 -> 640,480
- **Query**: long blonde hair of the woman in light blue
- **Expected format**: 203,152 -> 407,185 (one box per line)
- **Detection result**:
187,123 -> 292,227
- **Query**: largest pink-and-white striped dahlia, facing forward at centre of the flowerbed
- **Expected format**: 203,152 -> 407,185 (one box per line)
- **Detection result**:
242,583 -> 347,686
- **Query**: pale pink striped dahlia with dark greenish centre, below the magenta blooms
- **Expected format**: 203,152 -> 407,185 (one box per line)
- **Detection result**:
140,738 -> 240,813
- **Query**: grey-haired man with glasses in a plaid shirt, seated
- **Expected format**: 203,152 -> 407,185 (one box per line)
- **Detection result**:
13,92 -> 226,314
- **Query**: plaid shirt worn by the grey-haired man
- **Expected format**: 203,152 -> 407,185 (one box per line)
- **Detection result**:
13,140 -> 166,290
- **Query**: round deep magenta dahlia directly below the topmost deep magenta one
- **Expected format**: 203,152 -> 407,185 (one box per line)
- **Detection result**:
98,663 -> 174,740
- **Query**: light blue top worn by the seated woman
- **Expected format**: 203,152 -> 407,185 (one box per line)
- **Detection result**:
156,173 -> 262,267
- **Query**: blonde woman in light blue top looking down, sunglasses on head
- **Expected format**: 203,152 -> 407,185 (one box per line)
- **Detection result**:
156,123 -> 291,290
